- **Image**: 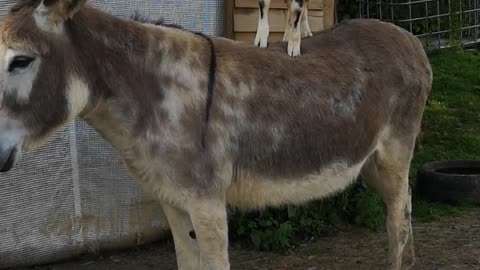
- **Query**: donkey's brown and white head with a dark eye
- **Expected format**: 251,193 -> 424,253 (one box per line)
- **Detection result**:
0,0 -> 89,172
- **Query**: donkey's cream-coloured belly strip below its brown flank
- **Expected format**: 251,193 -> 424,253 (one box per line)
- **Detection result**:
227,162 -> 364,209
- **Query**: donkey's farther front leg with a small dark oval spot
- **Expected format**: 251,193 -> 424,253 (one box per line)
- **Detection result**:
162,204 -> 200,270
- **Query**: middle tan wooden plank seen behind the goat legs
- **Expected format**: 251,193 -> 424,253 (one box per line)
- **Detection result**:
233,9 -> 323,32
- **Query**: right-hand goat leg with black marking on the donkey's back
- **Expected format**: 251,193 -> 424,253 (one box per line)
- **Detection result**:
287,0 -> 304,57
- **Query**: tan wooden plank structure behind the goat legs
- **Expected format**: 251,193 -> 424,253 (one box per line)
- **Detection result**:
225,0 -> 335,43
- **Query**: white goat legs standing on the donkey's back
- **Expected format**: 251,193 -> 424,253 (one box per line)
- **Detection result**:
255,0 -> 313,57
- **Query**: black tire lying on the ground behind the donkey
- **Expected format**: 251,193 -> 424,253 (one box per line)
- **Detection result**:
417,160 -> 480,205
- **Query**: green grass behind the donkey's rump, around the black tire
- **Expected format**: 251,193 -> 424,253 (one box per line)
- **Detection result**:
410,48 -> 480,221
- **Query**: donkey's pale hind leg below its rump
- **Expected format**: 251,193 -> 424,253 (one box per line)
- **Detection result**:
361,138 -> 415,270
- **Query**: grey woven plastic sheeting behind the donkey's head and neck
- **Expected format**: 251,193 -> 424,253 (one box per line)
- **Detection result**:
0,0 -> 224,268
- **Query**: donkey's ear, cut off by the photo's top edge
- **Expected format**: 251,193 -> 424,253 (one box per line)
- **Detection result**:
35,0 -> 87,30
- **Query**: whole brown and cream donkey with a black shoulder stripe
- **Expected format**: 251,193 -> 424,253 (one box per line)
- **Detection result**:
0,0 -> 432,270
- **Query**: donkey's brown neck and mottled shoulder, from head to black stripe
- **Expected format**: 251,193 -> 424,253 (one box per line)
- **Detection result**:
71,8 -> 210,148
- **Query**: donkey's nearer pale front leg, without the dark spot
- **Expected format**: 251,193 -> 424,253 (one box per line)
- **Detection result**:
190,198 -> 230,270
